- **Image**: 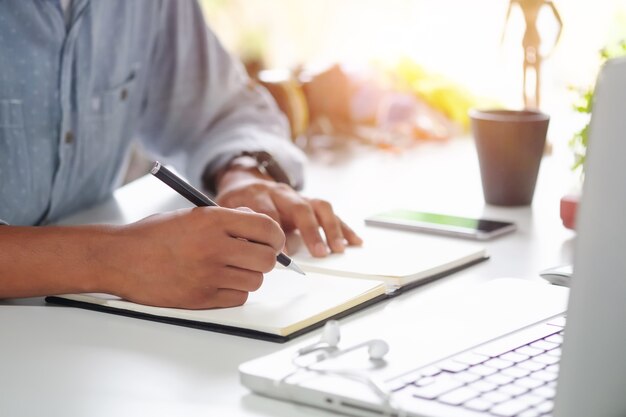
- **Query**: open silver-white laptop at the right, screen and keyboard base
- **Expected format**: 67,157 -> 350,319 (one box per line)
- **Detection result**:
239,59 -> 626,417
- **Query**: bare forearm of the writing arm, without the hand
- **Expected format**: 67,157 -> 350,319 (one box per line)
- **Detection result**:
0,226 -> 120,298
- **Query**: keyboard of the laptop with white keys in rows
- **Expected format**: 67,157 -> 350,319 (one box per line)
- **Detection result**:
388,316 -> 565,417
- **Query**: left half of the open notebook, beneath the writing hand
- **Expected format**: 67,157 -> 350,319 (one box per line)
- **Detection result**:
47,267 -> 385,342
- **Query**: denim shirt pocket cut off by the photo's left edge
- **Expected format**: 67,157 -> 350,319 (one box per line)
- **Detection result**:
0,99 -> 32,224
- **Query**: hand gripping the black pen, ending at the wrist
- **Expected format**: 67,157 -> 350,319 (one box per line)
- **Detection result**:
111,207 -> 285,309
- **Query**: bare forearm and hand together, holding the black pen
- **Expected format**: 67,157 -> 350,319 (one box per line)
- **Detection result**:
0,207 -> 285,309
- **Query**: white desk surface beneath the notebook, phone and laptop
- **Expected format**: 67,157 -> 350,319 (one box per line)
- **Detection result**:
0,140 -> 575,417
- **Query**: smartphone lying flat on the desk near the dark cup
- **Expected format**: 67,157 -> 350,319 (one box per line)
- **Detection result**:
365,210 -> 516,240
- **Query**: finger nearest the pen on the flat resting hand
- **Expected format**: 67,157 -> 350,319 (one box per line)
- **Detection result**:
274,193 -> 328,258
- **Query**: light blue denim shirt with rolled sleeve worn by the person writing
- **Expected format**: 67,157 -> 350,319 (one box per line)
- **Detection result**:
0,0 -> 303,225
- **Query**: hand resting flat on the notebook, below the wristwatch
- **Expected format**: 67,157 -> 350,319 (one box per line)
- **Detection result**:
217,165 -> 363,257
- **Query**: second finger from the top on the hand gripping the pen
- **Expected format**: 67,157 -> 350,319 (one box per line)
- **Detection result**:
223,234 -> 278,272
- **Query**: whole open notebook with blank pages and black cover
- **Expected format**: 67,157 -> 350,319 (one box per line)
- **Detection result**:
46,228 -> 487,342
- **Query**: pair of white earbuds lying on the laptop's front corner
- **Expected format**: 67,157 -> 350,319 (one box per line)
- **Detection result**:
298,320 -> 389,360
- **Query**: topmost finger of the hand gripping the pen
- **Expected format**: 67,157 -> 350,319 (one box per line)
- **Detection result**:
222,209 -> 285,252
